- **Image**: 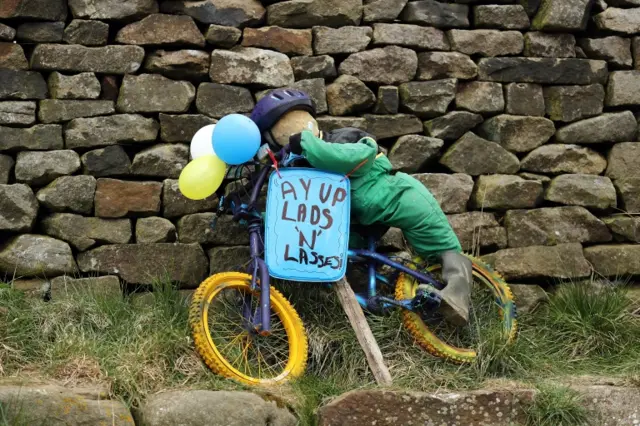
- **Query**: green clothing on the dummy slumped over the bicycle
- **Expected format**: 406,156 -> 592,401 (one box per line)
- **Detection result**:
301,131 -> 461,258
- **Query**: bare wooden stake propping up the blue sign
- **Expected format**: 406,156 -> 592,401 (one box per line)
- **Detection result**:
335,278 -> 391,386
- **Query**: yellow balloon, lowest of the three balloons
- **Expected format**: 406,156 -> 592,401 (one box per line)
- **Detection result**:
178,154 -> 227,200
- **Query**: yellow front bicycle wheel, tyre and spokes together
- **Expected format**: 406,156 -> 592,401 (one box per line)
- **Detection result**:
189,272 -> 308,385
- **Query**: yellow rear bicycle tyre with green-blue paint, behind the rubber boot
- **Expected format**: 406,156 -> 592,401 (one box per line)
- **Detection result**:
395,256 -> 517,363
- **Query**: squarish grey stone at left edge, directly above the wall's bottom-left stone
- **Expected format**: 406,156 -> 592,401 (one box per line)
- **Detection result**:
0,183 -> 38,232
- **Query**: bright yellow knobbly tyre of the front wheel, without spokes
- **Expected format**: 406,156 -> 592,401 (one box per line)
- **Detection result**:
189,272 -> 308,386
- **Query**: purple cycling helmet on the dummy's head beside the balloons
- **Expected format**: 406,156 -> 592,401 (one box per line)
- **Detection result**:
251,89 -> 316,133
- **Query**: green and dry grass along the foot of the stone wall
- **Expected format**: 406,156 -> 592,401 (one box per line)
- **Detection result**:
0,274 -> 640,425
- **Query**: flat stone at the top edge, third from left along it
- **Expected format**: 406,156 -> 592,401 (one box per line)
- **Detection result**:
160,0 -> 266,28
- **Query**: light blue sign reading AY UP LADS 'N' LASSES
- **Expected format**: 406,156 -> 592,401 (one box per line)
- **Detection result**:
265,168 -> 351,282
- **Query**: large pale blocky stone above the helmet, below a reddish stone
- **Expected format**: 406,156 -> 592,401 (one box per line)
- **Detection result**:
209,47 -> 294,88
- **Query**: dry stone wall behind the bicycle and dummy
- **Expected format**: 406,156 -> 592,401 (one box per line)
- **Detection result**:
0,0 -> 640,288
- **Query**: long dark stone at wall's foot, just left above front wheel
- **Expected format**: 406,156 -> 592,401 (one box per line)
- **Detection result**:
78,243 -> 209,288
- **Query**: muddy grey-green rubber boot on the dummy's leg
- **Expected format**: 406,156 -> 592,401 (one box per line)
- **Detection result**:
439,251 -> 473,326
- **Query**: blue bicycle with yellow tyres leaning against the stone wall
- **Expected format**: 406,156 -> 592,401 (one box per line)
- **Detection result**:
189,148 -> 517,385
